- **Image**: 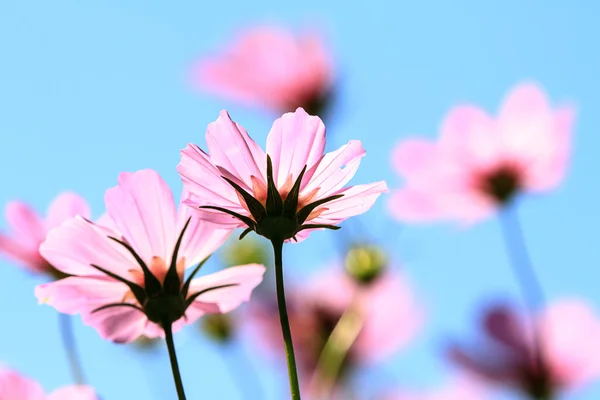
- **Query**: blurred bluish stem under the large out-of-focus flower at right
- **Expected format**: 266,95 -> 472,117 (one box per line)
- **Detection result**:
500,205 -> 549,400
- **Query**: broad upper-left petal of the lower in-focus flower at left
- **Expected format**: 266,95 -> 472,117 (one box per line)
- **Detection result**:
40,216 -> 134,277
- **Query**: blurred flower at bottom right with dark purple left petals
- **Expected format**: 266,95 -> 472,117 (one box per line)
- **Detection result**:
450,300 -> 600,398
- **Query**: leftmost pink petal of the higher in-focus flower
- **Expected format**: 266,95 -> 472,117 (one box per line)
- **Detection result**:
177,144 -> 243,212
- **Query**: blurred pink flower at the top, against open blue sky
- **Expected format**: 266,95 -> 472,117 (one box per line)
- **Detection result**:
193,27 -> 333,116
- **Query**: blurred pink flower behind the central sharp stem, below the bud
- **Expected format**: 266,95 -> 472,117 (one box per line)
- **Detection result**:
250,268 -> 423,379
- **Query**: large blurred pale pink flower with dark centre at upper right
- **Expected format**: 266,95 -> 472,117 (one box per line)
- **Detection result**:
389,83 -> 575,223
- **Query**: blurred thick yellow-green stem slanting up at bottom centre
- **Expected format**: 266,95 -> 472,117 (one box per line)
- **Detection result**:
311,292 -> 364,399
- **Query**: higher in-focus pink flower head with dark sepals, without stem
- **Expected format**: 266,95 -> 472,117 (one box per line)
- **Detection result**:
178,108 -> 387,240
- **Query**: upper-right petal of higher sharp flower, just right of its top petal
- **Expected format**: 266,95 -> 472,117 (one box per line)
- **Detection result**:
301,140 -> 366,198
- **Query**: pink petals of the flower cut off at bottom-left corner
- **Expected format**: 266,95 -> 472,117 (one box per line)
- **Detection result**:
0,367 -> 98,400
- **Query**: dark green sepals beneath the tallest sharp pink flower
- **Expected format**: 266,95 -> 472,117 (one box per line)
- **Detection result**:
200,155 -> 344,241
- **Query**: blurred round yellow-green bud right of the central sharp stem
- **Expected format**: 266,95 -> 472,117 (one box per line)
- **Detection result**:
344,245 -> 387,284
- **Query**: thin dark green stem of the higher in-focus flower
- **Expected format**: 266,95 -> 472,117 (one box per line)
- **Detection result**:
271,240 -> 300,400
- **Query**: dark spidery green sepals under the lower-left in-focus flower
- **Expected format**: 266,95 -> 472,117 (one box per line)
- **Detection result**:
86,219 -> 237,327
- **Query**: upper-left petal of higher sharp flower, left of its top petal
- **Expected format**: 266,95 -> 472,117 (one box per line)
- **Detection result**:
206,110 -> 267,188
